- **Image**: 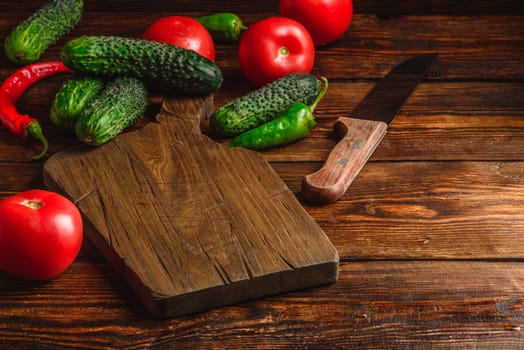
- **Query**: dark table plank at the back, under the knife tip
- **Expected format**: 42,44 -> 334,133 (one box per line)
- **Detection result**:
0,12 -> 524,80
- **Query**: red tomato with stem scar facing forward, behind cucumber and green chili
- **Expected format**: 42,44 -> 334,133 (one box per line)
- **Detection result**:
238,17 -> 315,86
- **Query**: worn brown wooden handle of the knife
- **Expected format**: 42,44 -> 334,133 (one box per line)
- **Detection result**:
302,117 -> 387,204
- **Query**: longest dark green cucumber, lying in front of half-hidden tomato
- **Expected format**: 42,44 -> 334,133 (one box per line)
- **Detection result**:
61,36 -> 223,95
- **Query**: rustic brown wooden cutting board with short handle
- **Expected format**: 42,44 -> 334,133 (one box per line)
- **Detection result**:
44,96 -> 338,317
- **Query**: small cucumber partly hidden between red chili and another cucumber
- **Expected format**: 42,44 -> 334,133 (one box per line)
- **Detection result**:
50,76 -> 104,130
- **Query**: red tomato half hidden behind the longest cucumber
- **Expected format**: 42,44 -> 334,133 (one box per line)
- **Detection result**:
142,16 -> 215,61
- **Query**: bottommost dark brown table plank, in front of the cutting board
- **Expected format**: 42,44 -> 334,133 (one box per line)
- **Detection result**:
0,261 -> 524,349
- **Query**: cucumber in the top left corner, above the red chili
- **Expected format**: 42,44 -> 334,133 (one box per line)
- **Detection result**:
4,0 -> 84,65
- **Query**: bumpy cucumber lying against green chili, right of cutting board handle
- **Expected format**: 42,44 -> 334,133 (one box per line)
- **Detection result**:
210,73 -> 321,136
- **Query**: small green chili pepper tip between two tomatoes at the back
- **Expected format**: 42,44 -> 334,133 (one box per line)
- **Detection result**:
196,12 -> 247,43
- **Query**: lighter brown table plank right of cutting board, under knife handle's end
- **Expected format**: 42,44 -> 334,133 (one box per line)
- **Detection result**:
273,161 -> 524,259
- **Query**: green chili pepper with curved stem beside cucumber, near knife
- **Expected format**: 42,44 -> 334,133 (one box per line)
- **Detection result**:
229,77 -> 328,150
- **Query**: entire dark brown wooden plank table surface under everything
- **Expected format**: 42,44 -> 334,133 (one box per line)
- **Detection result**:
0,0 -> 524,349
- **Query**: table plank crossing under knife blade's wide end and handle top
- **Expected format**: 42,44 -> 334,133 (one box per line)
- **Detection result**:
0,81 -> 524,162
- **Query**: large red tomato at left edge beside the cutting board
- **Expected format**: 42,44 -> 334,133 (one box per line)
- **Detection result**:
0,190 -> 83,280
